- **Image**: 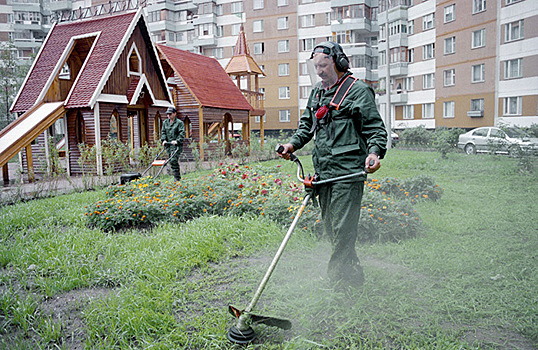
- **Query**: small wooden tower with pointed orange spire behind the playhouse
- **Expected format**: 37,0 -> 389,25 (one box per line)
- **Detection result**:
224,25 -> 265,149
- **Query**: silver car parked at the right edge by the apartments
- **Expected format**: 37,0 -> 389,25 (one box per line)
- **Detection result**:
458,126 -> 538,154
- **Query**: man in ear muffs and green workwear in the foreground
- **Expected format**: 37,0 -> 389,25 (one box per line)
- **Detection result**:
280,42 -> 387,287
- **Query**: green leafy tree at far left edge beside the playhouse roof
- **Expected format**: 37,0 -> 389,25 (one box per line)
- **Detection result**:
0,42 -> 30,130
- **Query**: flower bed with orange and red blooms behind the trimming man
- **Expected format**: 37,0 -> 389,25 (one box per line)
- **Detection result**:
86,164 -> 441,240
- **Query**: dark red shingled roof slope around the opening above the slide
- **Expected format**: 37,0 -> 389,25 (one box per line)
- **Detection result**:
12,12 -> 137,112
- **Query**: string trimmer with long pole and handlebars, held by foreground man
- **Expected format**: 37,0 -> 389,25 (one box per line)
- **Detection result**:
227,145 -> 373,344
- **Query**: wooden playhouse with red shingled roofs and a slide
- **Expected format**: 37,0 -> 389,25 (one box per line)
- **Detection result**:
0,9 -> 263,182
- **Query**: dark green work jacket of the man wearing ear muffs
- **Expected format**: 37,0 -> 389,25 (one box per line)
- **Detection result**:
290,72 -> 387,181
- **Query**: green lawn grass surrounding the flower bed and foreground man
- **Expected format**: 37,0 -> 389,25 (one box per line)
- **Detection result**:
0,149 -> 538,349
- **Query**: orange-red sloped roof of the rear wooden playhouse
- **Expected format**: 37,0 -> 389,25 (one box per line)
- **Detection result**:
157,45 -> 252,110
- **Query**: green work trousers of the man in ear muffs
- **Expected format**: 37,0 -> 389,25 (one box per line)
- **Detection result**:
316,181 -> 364,285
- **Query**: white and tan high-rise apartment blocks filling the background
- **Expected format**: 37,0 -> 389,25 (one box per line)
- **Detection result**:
0,0 -> 538,133
